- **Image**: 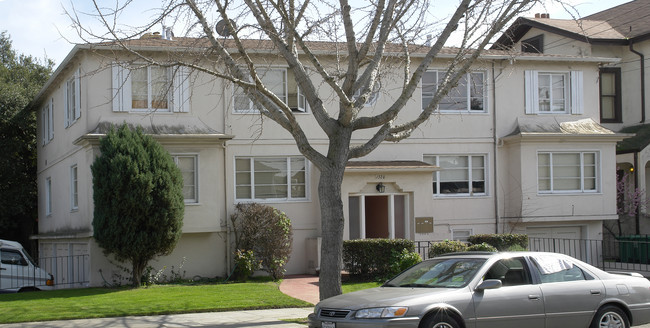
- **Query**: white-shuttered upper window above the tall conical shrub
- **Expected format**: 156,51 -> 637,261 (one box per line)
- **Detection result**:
111,63 -> 191,113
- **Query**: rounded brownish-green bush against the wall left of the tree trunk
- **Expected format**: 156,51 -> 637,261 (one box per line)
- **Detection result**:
230,203 -> 293,280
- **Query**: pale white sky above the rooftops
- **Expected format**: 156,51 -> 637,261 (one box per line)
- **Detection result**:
0,0 -> 629,69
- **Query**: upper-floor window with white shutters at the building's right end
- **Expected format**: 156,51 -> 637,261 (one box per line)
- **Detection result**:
524,71 -> 584,114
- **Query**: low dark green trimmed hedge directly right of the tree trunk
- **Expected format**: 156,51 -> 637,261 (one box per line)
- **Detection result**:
343,239 -> 419,280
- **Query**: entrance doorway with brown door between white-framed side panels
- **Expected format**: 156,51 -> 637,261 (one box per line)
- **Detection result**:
348,194 -> 409,239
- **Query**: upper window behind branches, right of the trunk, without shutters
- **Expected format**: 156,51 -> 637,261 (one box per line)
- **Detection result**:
422,70 -> 487,113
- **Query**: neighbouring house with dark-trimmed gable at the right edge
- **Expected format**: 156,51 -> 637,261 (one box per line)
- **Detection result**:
493,0 -> 650,234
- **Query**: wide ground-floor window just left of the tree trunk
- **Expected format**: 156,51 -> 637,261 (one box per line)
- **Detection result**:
235,157 -> 308,200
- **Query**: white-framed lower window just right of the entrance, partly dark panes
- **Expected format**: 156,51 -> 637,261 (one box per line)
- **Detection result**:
424,154 -> 489,197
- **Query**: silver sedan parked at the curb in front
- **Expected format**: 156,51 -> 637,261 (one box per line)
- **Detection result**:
309,252 -> 650,328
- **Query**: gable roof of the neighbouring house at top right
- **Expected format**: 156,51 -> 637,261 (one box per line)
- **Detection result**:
492,0 -> 650,49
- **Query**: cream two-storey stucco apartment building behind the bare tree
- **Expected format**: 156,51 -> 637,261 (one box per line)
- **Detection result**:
33,34 -> 622,285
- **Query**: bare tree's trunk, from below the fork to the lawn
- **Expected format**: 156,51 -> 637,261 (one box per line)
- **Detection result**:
318,167 -> 345,300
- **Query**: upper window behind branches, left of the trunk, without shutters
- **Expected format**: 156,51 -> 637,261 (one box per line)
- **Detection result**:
233,68 -> 309,113
